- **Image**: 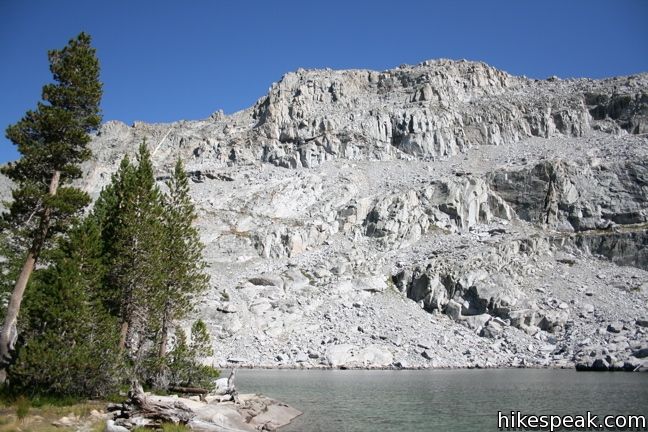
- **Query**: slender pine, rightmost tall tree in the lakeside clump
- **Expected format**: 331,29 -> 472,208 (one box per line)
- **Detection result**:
157,159 -> 209,358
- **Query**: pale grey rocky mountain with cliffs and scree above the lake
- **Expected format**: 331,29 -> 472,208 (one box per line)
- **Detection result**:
5,60 -> 648,370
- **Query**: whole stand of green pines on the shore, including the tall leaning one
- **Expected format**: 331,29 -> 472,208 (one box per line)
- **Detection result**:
0,33 -> 218,397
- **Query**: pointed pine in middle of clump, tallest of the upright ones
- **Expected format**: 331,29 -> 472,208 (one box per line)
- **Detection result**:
94,143 -> 167,358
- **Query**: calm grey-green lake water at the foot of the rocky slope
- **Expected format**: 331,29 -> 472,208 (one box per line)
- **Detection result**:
234,369 -> 648,432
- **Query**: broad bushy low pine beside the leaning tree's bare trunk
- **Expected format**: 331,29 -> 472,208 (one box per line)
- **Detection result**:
8,218 -> 121,396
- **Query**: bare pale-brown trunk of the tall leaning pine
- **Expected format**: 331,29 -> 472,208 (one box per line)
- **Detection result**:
0,171 -> 61,383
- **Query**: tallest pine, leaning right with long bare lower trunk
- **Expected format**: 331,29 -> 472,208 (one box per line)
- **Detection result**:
0,33 -> 102,380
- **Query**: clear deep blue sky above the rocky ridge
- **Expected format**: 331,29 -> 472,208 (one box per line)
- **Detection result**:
0,0 -> 648,163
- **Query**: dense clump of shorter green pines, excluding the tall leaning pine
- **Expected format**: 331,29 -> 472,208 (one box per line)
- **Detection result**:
9,144 -> 218,396
